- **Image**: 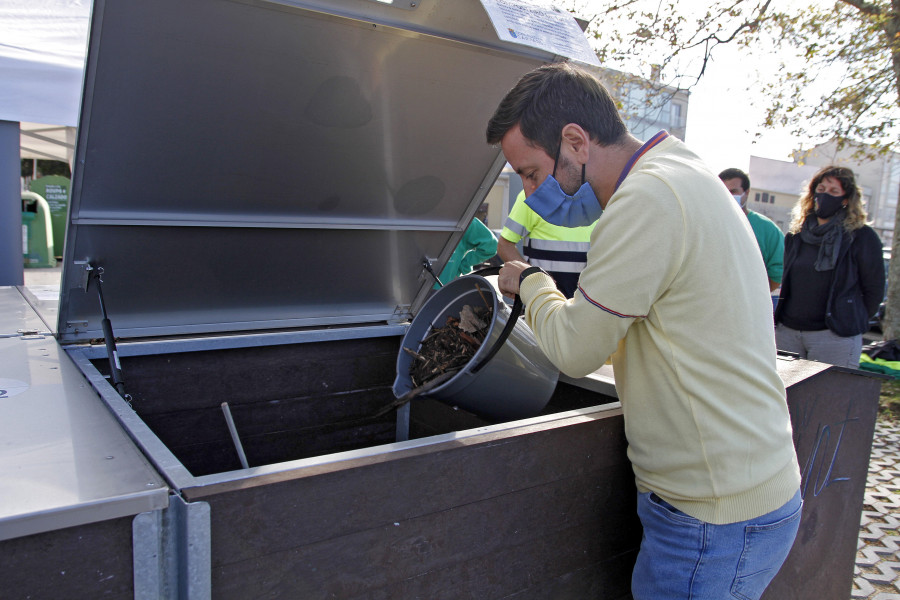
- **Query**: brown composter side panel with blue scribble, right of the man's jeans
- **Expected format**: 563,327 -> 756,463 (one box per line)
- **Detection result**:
763,368 -> 881,600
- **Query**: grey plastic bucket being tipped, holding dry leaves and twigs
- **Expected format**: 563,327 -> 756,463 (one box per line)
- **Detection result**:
394,275 -> 559,421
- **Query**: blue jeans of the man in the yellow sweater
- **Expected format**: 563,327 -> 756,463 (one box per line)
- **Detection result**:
631,491 -> 802,600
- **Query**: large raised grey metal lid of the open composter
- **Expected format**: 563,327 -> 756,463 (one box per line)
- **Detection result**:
58,0 -> 586,342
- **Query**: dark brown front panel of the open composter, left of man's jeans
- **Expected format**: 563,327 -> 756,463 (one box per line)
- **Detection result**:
204,411 -> 640,598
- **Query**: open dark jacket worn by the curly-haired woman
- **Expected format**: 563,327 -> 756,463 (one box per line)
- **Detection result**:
775,226 -> 884,337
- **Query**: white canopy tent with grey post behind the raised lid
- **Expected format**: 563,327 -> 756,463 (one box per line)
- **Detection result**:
0,0 -> 91,285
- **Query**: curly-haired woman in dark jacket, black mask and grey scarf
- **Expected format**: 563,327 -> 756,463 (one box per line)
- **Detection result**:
775,166 -> 884,368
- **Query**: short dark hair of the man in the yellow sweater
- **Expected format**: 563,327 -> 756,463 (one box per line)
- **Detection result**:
486,63 -> 628,156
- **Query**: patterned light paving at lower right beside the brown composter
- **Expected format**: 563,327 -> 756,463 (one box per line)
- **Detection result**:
852,421 -> 900,600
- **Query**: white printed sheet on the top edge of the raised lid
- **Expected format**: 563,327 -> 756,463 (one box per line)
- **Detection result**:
481,0 -> 600,67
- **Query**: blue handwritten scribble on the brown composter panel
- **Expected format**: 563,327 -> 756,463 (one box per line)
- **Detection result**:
797,398 -> 859,498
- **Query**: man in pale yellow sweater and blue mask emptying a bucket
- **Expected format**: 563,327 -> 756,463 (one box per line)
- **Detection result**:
487,64 -> 801,600
